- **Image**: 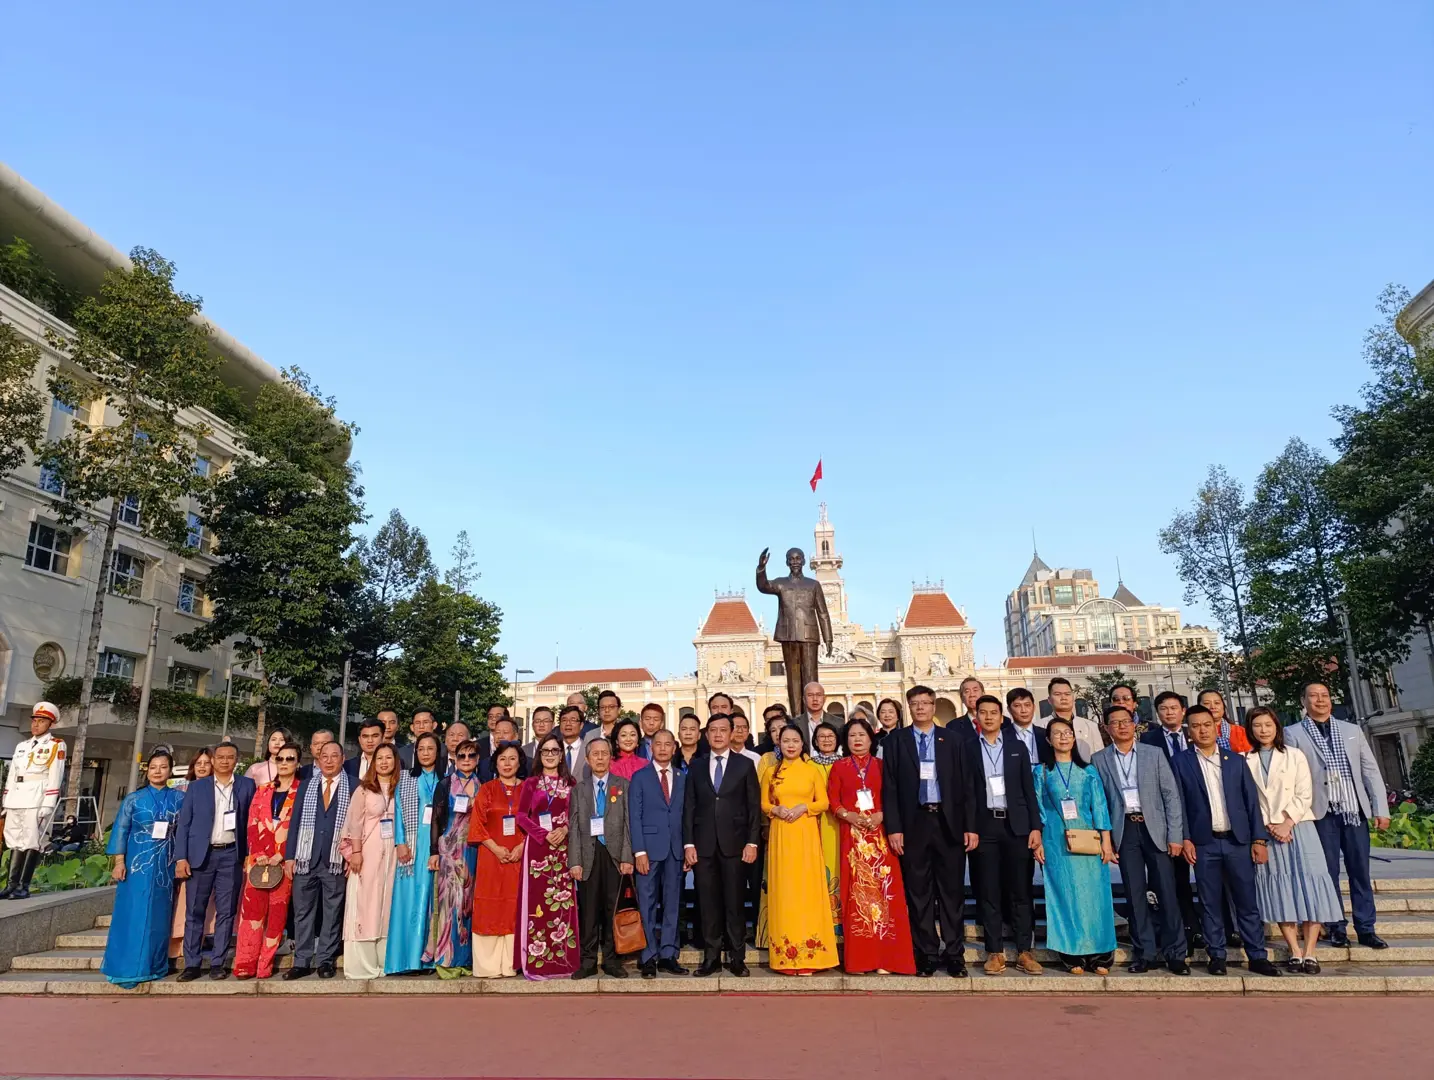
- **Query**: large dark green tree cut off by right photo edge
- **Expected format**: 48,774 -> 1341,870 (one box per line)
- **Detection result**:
1326,285 -> 1434,682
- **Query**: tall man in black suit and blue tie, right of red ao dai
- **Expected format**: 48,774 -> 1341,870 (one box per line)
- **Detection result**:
882,686 -> 977,978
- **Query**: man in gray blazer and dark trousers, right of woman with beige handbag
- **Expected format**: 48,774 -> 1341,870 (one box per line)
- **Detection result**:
1091,704 -> 1190,975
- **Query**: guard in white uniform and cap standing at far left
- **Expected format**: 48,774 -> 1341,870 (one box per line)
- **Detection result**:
0,701 -> 65,899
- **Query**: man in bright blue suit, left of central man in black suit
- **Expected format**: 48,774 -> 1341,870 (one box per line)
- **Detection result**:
628,727 -> 687,978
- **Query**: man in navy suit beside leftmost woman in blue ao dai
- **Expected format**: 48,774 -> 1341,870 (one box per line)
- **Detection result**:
175,743 -> 254,982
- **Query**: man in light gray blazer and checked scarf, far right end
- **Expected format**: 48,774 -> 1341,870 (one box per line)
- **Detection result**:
1285,683 -> 1390,948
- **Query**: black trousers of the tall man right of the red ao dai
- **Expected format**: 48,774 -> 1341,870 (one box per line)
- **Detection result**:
901,809 -> 967,967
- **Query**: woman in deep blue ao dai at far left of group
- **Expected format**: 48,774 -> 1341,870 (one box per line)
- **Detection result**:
100,750 -> 184,990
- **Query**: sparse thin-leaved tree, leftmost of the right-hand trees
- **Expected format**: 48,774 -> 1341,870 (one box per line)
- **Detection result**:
1160,465 -> 1255,694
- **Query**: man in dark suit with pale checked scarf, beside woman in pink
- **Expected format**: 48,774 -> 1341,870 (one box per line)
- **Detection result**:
284,743 -> 357,981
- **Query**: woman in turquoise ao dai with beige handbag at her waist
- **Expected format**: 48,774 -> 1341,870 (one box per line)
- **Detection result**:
1034,716 -> 1116,975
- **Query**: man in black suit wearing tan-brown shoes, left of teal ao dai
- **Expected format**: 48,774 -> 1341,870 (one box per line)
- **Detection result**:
961,694 -> 1041,975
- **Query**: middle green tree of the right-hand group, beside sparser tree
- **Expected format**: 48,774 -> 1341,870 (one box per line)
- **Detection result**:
1240,439 -> 1357,706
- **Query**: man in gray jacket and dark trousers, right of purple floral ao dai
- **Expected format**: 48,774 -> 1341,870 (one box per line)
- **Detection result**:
568,736 -> 632,978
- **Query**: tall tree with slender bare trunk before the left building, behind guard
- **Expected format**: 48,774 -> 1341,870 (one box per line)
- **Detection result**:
40,248 -> 219,797
